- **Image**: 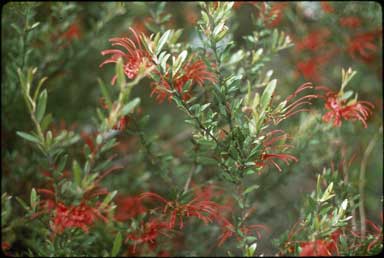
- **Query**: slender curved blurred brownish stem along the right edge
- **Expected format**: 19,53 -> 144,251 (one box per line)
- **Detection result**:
359,127 -> 383,238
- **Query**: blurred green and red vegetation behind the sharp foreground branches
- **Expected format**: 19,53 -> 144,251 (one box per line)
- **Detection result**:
1,2 -> 383,255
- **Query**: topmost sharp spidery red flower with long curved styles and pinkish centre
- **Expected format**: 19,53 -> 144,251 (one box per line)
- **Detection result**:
99,28 -> 151,85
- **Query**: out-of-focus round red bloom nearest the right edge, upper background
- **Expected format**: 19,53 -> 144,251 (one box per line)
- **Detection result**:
347,31 -> 378,63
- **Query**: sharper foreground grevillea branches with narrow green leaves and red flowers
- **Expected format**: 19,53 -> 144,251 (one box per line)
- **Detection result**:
2,2 -> 380,256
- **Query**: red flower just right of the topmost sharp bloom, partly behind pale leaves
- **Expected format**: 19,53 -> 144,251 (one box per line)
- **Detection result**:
151,59 -> 217,103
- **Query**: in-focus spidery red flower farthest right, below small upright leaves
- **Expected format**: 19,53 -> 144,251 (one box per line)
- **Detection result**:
316,86 -> 374,128
